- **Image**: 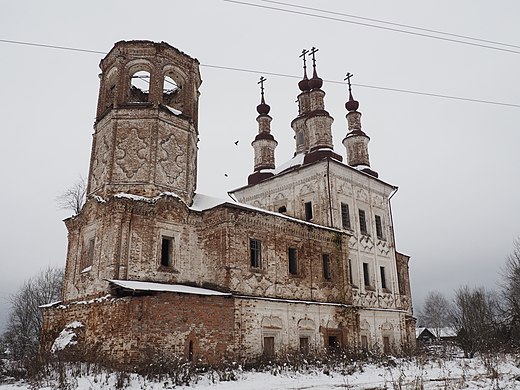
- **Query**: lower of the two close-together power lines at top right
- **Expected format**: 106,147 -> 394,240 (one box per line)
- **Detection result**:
223,0 -> 520,54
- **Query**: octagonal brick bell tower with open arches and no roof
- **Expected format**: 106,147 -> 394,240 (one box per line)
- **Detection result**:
87,41 -> 201,205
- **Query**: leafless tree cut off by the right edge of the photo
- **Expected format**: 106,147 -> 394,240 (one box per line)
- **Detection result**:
502,238 -> 520,344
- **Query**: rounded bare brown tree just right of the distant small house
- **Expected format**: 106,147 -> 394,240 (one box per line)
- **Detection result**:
450,286 -> 498,357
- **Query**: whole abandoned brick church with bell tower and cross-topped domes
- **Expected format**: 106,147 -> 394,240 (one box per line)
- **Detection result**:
42,41 -> 415,366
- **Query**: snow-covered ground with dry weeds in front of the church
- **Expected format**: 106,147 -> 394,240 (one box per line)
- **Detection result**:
0,356 -> 520,390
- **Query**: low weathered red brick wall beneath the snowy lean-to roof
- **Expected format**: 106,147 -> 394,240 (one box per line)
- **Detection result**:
42,293 -> 235,367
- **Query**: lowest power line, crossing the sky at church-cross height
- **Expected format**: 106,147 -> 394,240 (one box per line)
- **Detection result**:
0,38 -> 520,108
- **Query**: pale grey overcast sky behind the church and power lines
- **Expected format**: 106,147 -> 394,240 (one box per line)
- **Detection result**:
0,0 -> 520,327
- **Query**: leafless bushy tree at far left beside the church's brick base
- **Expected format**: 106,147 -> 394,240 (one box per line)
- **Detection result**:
3,267 -> 63,360
